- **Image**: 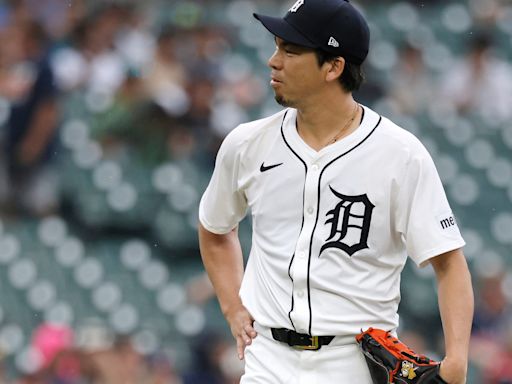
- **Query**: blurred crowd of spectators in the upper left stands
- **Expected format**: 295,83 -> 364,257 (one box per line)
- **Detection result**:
0,0 -> 262,214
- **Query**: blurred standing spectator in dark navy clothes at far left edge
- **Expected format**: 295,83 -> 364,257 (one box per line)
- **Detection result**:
1,22 -> 59,215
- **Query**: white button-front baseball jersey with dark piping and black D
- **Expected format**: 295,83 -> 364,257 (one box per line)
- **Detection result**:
199,107 -> 464,336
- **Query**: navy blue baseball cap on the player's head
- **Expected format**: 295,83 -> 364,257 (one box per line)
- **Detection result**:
253,0 -> 370,65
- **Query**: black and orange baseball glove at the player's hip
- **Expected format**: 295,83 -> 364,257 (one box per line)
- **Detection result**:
356,328 -> 447,384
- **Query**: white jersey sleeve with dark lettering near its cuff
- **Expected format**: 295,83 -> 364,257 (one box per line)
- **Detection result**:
396,142 -> 465,266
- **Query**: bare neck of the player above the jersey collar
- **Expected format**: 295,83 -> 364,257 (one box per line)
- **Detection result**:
297,93 -> 361,151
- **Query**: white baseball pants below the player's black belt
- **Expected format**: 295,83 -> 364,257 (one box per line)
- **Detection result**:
240,324 -> 372,384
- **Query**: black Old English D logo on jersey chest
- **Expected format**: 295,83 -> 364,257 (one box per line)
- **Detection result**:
320,186 -> 375,256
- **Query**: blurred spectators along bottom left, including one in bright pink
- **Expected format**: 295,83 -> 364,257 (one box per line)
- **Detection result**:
0,324 -> 243,384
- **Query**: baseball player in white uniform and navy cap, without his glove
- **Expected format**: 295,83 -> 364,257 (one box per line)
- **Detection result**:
199,0 -> 473,384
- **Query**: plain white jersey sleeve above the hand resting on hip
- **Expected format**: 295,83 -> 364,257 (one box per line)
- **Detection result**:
199,129 -> 247,234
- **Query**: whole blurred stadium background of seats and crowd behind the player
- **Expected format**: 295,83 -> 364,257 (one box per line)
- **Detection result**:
0,0 -> 512,384
